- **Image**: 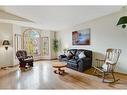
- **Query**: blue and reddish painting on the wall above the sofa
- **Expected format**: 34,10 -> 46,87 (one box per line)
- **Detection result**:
72,28 -> 90,45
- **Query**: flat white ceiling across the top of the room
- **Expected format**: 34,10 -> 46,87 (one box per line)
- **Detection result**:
0,6 -> 122,30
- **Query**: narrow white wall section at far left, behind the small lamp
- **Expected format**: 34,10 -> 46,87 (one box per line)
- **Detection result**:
0,23 -> 13,68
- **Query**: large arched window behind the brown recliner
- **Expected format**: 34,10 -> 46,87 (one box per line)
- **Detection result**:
23,29 -> 41,56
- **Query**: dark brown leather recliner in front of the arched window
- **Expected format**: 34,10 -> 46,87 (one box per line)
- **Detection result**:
16,50 -> 34,68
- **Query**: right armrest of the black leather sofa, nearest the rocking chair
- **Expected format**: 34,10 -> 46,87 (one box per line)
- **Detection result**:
77,57 -> 92,72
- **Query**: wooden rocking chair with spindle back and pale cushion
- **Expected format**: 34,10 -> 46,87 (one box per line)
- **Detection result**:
94,48 -> 121,83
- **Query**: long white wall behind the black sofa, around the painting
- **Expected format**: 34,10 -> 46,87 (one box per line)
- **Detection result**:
59,13 -> 127,73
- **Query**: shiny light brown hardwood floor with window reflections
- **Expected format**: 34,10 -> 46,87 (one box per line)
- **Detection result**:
0,61 -> 127,89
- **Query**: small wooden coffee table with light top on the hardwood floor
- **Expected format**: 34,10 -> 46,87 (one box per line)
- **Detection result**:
52,62 -> 67,75
